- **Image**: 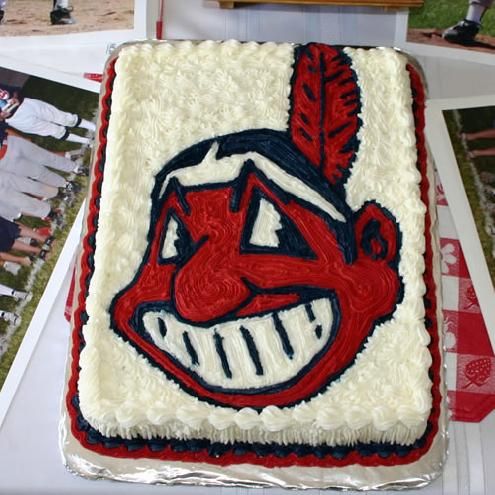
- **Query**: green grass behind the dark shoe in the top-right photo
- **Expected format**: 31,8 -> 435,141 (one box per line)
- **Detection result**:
409,0 -> 495,36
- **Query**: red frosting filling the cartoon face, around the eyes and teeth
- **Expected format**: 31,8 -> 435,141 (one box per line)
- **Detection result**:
111,176 -> 400,408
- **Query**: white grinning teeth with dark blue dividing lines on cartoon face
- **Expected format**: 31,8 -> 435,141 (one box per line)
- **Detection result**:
143,299 -> 334,389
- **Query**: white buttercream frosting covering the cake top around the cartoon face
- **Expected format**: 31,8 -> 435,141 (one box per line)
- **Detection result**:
78,41 -> 431,445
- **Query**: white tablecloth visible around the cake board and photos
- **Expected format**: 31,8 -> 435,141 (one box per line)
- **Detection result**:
0,0 -> 495,495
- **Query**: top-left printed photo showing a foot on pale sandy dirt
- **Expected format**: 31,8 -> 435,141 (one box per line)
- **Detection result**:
0,0 -> 134,36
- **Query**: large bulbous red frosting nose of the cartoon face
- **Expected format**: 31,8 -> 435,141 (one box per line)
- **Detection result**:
174,258 -> 251,323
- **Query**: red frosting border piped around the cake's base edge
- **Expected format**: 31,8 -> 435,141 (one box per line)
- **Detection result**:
66,53 -> 442,467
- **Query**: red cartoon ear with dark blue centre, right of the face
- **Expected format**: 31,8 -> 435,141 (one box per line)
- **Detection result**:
355,203 -> 400,262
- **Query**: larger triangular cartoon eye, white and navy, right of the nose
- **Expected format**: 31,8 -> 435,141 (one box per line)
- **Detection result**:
241,191 -> 316,259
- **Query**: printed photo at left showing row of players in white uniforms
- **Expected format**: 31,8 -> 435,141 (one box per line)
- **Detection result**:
0,67 -> 98,389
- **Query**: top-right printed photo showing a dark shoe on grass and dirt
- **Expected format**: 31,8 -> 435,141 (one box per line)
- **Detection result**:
407,0 -> 495,55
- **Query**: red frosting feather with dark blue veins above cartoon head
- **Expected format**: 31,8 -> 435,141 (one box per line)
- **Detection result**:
289,43 -> 361,184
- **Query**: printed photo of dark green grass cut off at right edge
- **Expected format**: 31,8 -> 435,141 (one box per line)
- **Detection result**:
443,106 -> 495,286
